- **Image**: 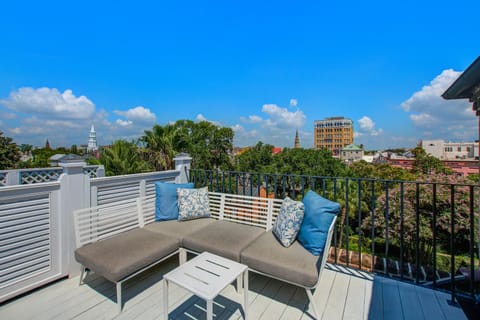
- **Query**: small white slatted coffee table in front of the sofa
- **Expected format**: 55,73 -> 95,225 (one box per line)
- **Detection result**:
163,252 -> 248,320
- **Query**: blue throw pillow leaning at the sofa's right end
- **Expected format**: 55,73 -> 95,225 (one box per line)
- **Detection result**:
297,191 -> 340,256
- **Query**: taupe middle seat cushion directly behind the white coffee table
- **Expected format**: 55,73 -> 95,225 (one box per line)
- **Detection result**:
182,220 -> 265,261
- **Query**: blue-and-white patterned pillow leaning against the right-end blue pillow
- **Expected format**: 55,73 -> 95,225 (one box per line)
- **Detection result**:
272,197 -> 304,247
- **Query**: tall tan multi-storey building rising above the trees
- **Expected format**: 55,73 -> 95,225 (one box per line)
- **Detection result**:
313,117 -> 353,156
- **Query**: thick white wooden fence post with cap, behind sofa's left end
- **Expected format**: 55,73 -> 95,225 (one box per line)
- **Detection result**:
59,158 -> 90,277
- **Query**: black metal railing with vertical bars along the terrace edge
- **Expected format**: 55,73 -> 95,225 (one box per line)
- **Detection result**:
189,169 -> 480,301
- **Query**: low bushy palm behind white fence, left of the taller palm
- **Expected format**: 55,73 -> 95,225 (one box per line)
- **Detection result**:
100,140 -> 151,176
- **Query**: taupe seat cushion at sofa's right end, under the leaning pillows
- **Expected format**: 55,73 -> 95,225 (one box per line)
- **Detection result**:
240,231 -> 321,287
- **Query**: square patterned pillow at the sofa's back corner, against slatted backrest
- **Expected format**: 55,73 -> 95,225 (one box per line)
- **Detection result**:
177,187 -> 210,221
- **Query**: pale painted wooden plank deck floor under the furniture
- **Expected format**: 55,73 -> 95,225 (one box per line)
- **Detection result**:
0,259 -> 466,320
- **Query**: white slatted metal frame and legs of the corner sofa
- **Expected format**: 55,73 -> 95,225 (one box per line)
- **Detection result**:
74,192 -> 336,318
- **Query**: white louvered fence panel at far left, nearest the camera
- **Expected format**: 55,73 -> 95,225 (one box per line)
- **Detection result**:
0,182 -> 64,302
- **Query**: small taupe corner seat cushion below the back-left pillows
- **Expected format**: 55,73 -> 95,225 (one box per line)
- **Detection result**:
145,218 -> 216,245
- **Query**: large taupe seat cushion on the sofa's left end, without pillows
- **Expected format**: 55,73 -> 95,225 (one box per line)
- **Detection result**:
75,229 -> 180,282
